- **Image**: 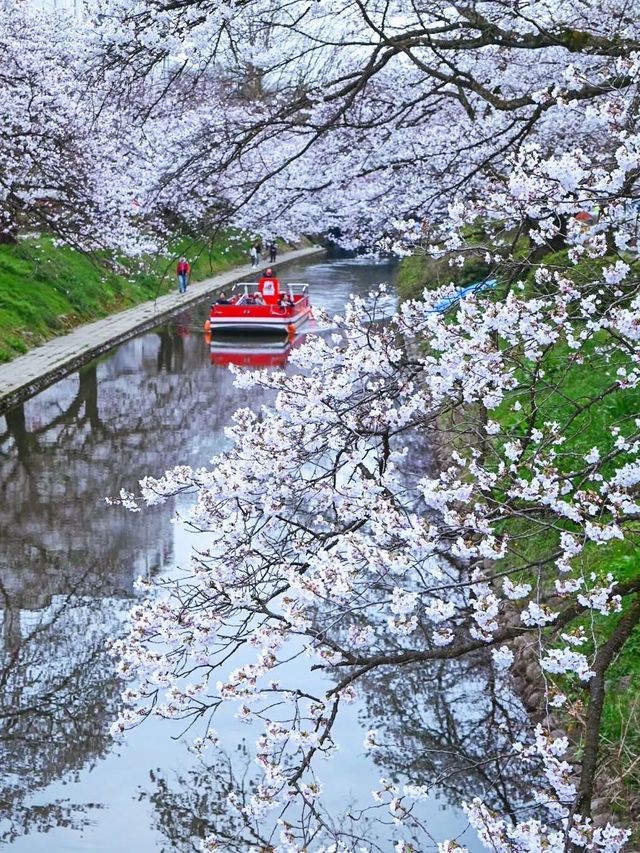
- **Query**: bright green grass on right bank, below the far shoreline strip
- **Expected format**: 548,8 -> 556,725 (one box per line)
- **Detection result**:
492,324 -> 640,820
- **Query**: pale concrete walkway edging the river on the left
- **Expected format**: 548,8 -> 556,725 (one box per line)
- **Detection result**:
0,246 -> 326,415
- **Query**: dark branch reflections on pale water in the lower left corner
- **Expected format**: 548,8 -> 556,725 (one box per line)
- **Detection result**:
0,578 -> 119,842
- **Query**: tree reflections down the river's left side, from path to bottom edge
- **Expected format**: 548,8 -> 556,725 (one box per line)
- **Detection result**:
0,316 -> 270,843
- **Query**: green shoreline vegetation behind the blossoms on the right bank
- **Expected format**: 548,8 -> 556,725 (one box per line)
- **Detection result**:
395,238 -> 640,849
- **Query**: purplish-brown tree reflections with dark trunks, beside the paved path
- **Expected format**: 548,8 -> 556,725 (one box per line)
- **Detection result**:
0,328 -> 240,609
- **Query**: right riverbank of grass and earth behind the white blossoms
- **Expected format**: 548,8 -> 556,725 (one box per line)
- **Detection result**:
396,240 -> 640,850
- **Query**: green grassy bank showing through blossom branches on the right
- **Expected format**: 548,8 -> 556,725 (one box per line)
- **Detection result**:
420,241 -> 640,832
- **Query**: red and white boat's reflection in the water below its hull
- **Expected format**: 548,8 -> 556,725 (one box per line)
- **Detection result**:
205,324 -> 310,368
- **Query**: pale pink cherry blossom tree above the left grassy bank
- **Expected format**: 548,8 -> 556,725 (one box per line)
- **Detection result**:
0,0 -> 185,254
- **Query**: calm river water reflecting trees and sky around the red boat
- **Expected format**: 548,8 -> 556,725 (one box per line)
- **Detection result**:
0,260 -> 528,853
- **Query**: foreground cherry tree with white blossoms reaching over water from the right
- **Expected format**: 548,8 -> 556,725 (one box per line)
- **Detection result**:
114,268 -> 640,850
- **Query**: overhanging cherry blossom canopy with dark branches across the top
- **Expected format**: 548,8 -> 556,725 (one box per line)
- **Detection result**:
89,0 -> 638,250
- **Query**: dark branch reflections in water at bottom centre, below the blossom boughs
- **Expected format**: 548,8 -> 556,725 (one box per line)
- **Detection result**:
140,654 -> 535,853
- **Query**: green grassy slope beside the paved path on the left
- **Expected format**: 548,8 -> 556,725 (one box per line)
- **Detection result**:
0,234 -> 251,362
